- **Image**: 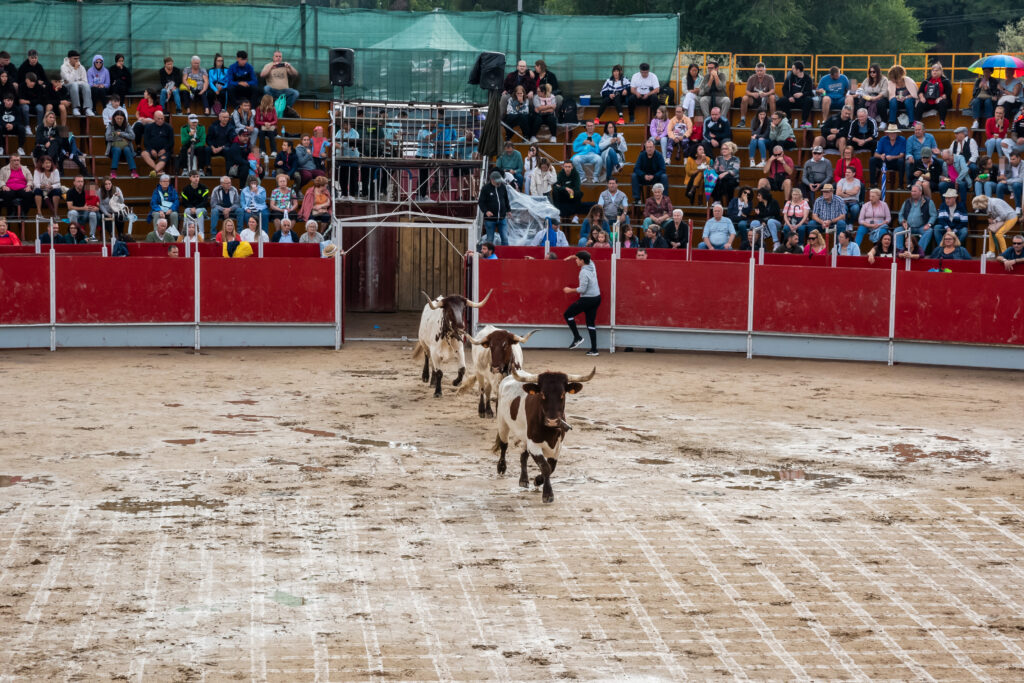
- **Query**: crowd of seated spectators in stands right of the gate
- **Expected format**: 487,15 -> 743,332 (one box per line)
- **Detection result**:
488,59 -> 1024,258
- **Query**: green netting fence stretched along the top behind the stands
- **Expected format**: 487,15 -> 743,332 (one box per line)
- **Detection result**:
0,1 -> 679,102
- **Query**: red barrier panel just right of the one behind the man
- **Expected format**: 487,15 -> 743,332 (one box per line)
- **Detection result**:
615,259 -> 750,330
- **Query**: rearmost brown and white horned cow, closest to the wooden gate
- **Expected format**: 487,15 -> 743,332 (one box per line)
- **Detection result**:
413,292 -> 490,398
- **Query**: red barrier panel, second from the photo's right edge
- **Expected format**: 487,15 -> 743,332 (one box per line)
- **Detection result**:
744,265 -> 891,337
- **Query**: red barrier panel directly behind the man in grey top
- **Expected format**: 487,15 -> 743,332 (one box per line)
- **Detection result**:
479,260 -> 622,325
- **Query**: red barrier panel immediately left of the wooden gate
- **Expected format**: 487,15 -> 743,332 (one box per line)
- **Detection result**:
202,258 -> 334,323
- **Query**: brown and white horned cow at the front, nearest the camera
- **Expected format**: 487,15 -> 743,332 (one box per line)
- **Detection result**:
494,368 -> 597,503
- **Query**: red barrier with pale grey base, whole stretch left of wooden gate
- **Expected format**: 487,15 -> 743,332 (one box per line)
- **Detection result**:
0,244 -> 343,350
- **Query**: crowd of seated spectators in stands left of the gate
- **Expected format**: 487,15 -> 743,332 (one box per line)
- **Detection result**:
0,50 -> 332,250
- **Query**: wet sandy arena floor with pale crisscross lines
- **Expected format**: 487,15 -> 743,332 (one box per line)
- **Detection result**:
0,350 -> 1024,681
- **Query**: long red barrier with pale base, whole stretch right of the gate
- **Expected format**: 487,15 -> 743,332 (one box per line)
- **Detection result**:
471,247 -> 1024,370
